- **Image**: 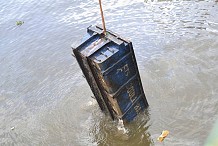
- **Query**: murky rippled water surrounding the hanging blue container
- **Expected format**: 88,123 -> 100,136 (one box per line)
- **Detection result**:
0,0 -> 218,146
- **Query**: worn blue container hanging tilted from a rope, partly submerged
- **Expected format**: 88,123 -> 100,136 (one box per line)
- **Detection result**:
73,26 -> 148,122
